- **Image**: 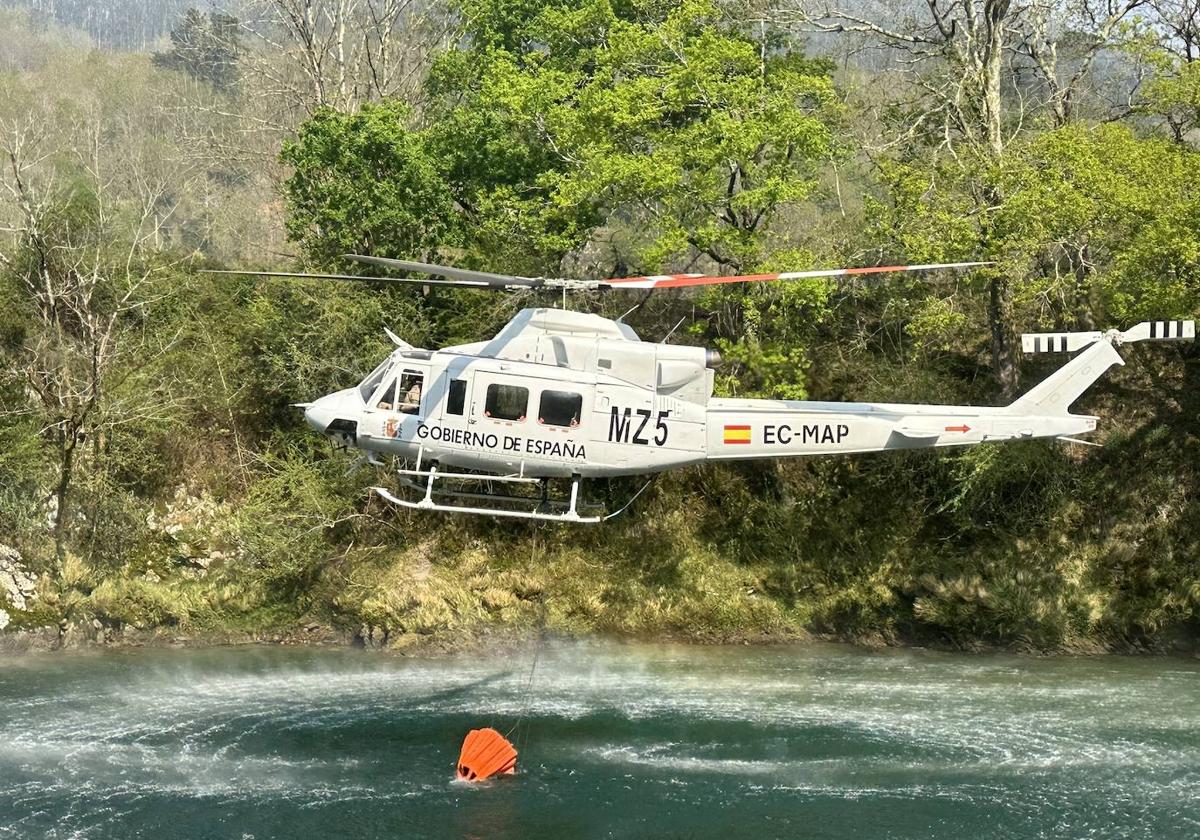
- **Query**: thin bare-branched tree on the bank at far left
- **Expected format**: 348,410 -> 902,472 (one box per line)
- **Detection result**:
0,90 -> 187,559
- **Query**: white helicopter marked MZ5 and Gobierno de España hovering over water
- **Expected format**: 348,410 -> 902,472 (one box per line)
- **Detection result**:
220,254 -> 1195,523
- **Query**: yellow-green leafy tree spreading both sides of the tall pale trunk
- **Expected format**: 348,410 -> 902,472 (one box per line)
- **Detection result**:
875,125 -> 1200,338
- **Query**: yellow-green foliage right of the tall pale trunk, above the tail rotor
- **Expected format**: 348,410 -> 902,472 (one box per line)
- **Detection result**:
994,125 -> 1200,324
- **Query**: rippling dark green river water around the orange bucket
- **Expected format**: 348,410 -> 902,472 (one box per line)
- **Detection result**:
0,642 -> 1200,840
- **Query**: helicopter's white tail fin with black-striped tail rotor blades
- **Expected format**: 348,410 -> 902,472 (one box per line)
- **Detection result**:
1008,320 -> 1196,415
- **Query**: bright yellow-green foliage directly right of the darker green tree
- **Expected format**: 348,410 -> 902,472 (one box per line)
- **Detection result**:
481,1 -> 836,266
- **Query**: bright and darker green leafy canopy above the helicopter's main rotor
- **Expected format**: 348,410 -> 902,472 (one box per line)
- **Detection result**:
284,0 -> 838,278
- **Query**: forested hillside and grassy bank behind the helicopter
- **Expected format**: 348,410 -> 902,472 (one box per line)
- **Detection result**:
0,0 -> 1200,649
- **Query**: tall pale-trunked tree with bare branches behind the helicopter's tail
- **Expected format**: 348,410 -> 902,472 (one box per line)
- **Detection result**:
773,0 -> 1147,395
